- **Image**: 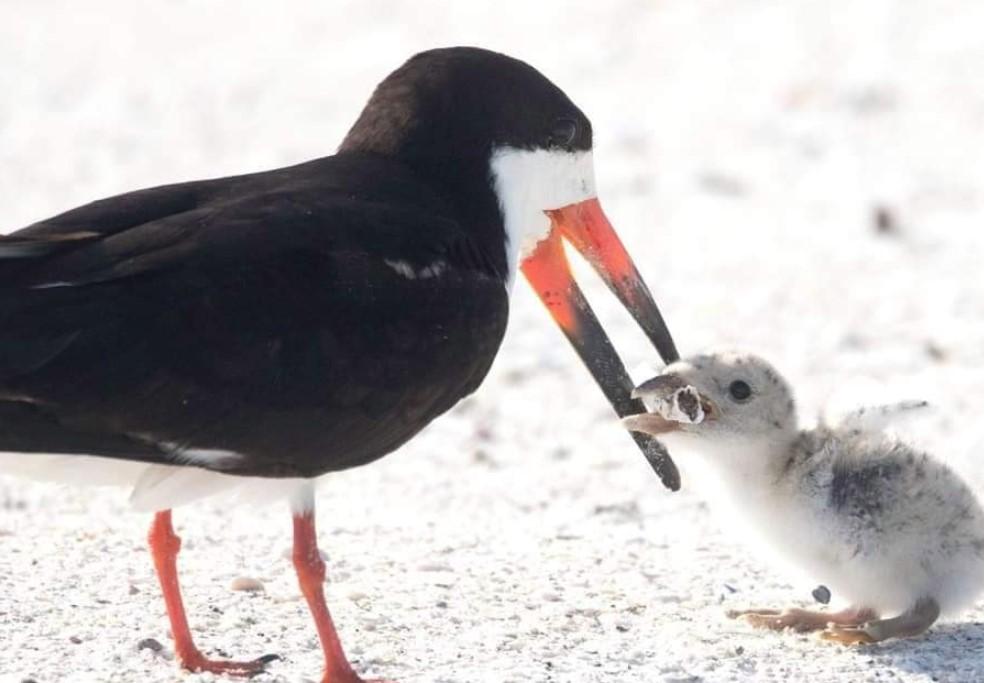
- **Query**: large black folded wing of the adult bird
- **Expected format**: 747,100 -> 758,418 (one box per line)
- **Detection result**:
0,157 -> 507,476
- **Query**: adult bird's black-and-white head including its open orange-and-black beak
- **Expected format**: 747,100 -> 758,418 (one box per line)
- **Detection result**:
339,48 -> 679,489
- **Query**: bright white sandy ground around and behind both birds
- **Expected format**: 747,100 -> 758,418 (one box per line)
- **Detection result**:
0,0 -> 984,683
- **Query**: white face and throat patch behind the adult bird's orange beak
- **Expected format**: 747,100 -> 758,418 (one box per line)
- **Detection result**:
489,147 -> 597,289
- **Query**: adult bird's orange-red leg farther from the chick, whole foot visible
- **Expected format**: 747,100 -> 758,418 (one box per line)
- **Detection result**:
147,510 -> 277,676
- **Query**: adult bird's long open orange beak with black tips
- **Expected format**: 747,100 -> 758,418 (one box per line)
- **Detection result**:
521,198 -> 680,491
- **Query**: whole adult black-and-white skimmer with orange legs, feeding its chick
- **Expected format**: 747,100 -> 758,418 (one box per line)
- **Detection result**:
0,48 -> 677,683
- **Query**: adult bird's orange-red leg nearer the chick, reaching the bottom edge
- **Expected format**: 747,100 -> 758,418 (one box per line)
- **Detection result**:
293,510 -> 385,683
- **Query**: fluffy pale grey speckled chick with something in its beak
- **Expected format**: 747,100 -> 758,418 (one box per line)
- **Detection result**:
625,353 -> 984,644
